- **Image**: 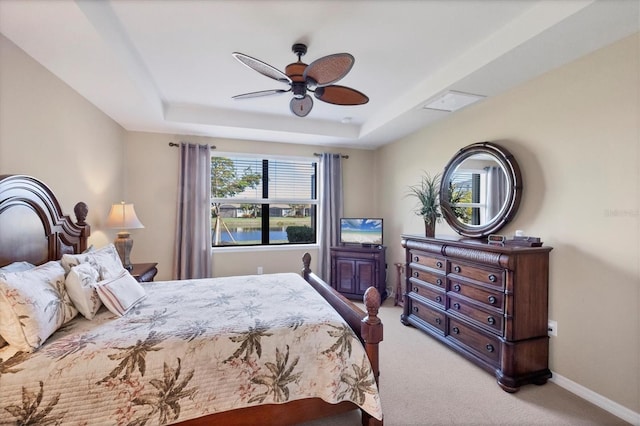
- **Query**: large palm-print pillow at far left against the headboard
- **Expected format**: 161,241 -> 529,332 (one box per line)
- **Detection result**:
0,261 -> 78,352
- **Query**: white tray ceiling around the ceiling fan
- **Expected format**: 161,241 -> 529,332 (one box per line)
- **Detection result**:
0,0 -> 640,148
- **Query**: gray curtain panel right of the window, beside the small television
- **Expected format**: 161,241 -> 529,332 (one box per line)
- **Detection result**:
317,153 -> 343,283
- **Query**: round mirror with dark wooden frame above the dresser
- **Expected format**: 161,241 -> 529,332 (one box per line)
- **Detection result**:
440,142 -> 522,238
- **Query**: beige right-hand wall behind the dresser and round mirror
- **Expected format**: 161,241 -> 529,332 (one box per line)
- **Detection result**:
376,35 -> 640,412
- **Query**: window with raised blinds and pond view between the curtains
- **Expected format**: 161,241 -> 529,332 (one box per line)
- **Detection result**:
211,155 -> 318,247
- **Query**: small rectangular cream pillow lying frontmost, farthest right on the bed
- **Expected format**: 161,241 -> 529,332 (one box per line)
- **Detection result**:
96,269 -> 147,316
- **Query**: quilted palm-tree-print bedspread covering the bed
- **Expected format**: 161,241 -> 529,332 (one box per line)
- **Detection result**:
0,273 -> 382,425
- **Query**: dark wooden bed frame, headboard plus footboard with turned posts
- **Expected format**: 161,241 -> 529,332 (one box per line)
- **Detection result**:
0,175 -> 382,425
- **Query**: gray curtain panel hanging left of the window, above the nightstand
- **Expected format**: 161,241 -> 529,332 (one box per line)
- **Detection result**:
173,143 -> 212,280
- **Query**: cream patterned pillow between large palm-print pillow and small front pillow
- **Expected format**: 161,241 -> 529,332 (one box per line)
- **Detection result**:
65,263 -> 102,320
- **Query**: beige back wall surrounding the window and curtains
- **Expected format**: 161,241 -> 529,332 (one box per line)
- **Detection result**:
125,132 -> 377,279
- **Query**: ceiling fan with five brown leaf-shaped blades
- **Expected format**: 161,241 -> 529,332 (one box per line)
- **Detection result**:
232,43 -> 369,117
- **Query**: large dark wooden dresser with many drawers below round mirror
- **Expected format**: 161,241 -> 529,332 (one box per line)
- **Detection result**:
401,235 -> 552,392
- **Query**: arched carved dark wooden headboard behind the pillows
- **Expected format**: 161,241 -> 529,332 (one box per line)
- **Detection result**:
0,175 -> 91,266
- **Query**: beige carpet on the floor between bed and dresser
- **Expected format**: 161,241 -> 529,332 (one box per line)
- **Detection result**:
305,299 -> 627,426
